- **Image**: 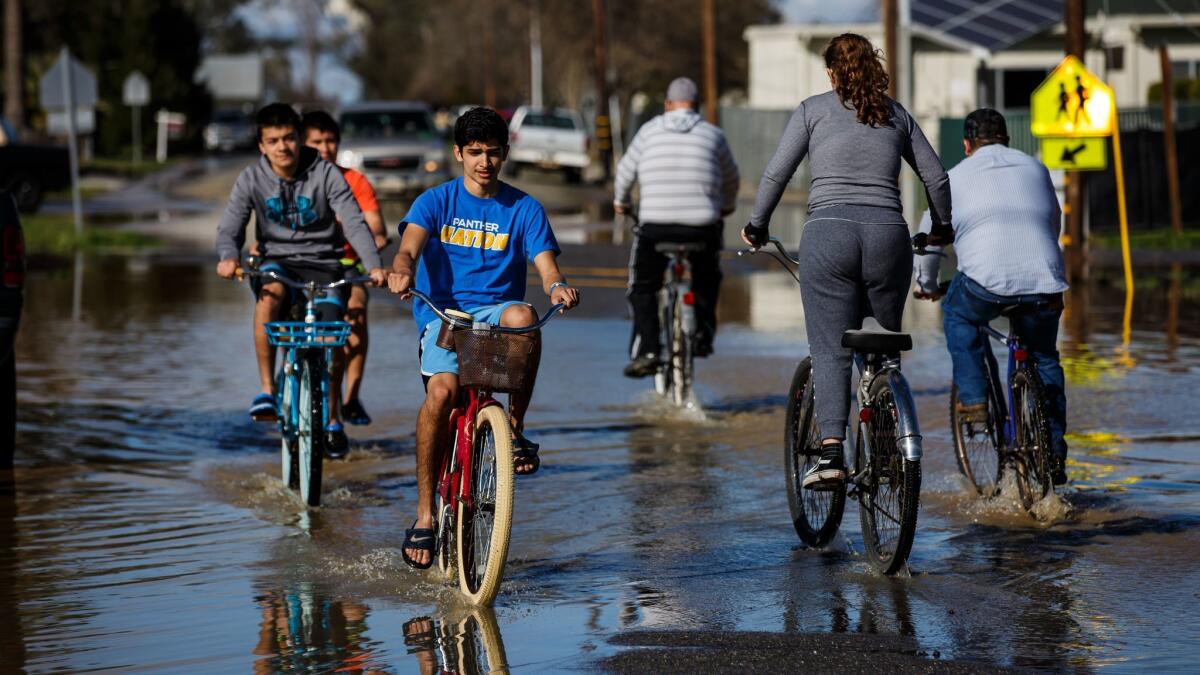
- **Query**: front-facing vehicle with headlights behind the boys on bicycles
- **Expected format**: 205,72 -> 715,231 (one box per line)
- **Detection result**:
337,101 -> 450,197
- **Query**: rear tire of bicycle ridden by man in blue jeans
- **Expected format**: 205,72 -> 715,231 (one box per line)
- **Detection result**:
1012,368 -> 1054,509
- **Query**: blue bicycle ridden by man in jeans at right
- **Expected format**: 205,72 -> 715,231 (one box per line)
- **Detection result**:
950,306 -> 1054,509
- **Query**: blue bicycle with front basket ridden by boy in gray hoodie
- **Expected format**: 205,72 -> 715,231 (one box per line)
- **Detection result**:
239,263 -> 371,506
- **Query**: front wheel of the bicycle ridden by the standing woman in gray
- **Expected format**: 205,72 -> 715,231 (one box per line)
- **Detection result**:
784,357 -> 846,548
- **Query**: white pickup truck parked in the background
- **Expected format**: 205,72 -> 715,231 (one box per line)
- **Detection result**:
509,106 -> 589,183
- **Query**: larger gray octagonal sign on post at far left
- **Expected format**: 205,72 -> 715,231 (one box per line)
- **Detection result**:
37,47 -> 96,237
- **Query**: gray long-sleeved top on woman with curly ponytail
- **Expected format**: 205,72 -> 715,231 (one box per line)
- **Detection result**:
750,91 -> 950,227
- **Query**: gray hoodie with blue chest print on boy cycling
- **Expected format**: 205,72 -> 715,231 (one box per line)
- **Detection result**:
217,148 -> 383,270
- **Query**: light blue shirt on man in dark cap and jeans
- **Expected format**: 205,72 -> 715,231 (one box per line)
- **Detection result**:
913,145 -> 1068,295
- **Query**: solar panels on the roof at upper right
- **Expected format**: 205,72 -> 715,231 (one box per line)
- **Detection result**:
912,0 -> 1063,52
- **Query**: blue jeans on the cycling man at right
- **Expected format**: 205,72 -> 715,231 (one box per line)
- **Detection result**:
942,273 -> 1067,458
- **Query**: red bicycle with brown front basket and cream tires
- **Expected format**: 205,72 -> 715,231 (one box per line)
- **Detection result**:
412,289 -> 564,605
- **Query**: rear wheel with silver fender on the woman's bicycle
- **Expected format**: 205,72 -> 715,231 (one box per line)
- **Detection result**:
856,374 -> 920,574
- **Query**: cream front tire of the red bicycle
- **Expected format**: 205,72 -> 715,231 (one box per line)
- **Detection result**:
456,406 -> 514,605
